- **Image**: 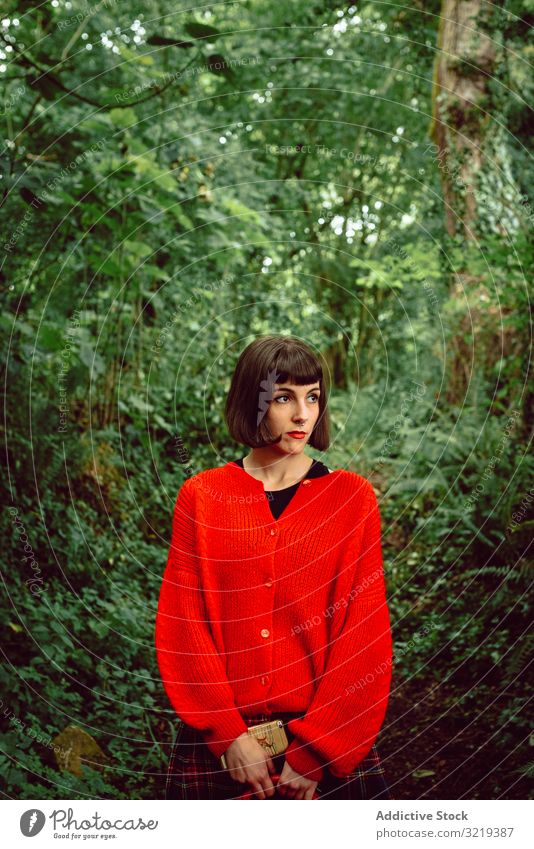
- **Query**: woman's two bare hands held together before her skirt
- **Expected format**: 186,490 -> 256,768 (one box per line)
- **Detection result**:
225,731 -> 319,799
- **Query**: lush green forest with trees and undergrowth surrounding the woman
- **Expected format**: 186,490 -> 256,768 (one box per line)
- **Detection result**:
0,0 -> 534,799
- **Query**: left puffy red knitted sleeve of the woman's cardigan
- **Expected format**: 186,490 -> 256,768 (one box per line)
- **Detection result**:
155,480 -> 247,757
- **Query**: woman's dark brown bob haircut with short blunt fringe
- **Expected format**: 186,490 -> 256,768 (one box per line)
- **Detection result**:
224,336 -> 330,451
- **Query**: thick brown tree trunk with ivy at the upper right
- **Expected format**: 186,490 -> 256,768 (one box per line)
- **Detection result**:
431,0 -> 507,404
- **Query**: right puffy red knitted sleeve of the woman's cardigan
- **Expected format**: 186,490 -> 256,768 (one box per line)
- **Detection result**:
286,482 -> 392,781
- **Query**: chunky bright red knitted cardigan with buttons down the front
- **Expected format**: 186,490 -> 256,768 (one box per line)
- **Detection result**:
155,463 -> 392,781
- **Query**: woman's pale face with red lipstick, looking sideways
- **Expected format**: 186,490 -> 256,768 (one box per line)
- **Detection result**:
267,382 -> 320,454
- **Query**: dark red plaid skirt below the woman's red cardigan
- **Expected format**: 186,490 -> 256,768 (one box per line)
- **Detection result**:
165,713 -> 393,801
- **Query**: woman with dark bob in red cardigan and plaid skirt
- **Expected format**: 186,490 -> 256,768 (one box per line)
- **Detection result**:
156,336 -> 392,799
